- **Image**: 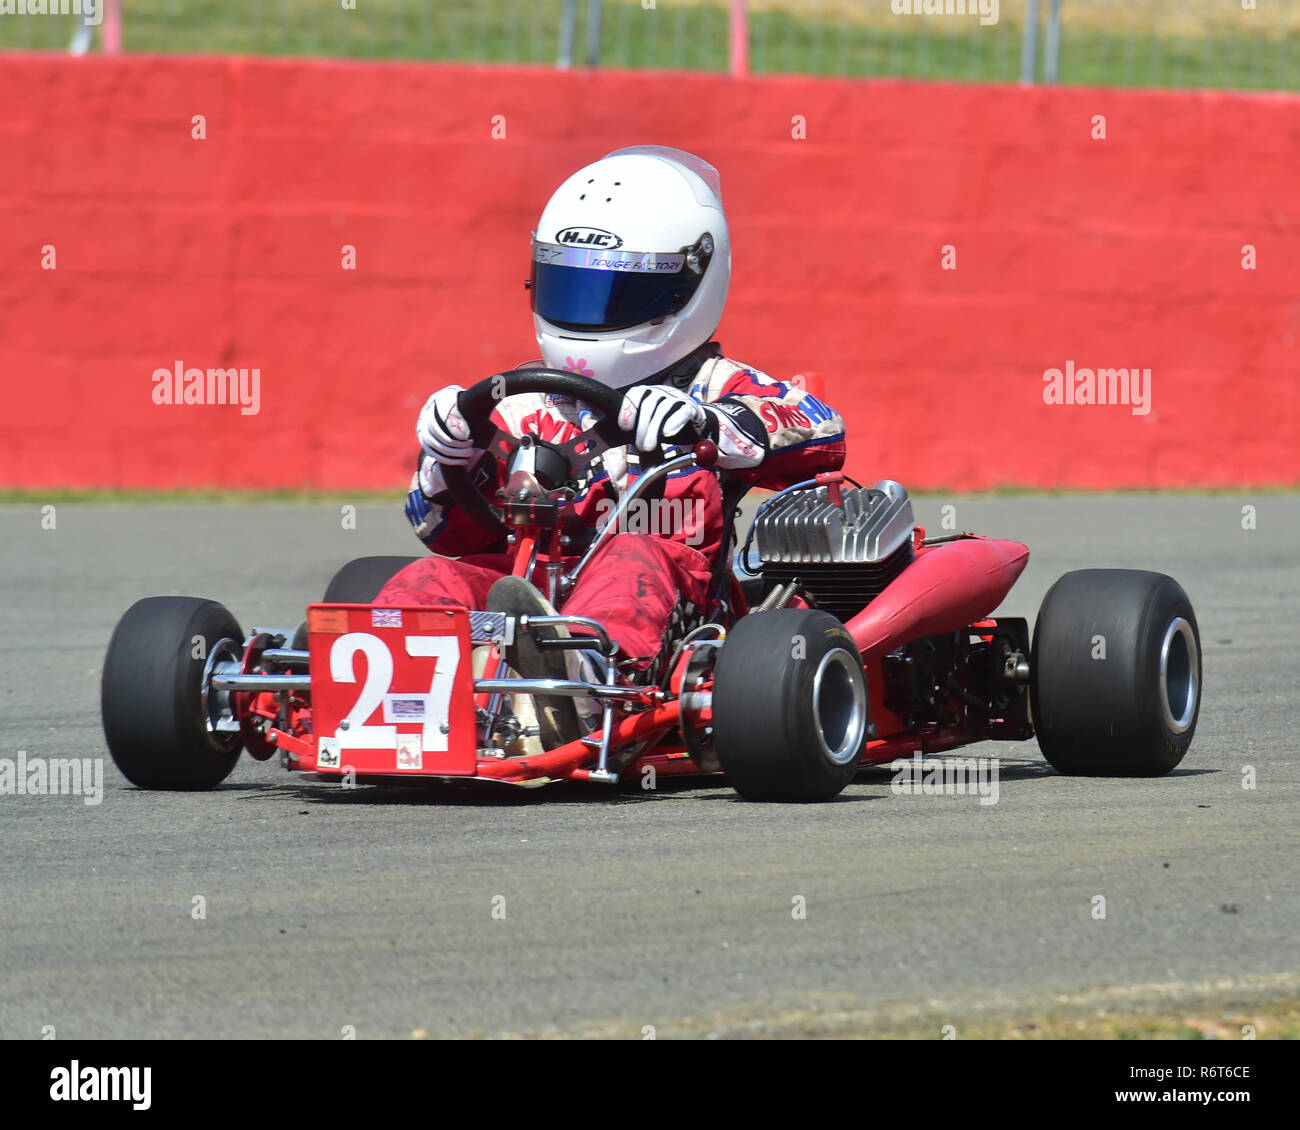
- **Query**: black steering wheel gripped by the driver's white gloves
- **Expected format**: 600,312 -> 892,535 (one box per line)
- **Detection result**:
442,369 -> 663,538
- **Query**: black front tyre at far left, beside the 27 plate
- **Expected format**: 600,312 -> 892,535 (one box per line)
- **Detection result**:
100,597 -> 243,789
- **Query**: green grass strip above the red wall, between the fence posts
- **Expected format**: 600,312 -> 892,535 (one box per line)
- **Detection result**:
0,0 -> 1300,90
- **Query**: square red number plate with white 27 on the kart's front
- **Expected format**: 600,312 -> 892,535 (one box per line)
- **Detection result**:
303,605 -> 477,776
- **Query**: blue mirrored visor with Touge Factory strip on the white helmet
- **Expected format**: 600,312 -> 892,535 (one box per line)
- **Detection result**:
532,239 -> 703,333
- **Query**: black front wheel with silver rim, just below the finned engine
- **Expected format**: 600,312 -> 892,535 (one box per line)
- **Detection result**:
712,609 -> 867,802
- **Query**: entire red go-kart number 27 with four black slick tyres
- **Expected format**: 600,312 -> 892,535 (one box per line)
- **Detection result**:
101,369 -> 1201,801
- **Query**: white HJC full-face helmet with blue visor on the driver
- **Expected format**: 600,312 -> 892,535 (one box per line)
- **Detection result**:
530,146 -> 731,389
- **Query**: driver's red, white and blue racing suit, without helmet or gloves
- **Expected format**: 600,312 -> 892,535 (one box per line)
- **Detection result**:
376,342 -> 845,667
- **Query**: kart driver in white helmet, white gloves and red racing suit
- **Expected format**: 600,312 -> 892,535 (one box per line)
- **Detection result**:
376,146 -> 845,749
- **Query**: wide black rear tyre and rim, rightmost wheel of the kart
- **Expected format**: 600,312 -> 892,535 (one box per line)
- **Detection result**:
1030,570 -> 1201,776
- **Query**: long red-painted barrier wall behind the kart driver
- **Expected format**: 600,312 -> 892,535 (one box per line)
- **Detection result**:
0,55 -> 1300,490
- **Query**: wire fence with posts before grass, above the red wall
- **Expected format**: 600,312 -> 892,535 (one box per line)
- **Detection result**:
0,0 -> 1300,90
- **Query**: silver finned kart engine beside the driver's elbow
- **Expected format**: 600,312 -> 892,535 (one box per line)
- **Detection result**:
754,479 -> 914,620
